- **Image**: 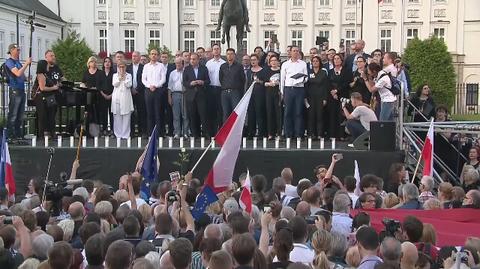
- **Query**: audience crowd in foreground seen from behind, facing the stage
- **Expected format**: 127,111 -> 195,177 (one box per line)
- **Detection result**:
0,151 -> 480,269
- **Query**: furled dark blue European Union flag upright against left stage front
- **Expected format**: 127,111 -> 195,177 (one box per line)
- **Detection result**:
141,125 -> 158,199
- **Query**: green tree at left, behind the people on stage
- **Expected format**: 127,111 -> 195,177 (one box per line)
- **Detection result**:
52,31 -> 93,81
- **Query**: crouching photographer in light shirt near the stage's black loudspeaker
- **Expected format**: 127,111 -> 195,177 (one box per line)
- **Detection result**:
342,92 -> 377,140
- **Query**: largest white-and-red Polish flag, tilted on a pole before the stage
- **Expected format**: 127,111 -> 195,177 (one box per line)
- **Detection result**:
205,83 -> 255,193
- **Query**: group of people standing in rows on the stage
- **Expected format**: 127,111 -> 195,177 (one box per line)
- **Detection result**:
3,40 -> 437,140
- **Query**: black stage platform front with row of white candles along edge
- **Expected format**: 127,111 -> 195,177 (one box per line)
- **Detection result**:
10,138 -> 404,194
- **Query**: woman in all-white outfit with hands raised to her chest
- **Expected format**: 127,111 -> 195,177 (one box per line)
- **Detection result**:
112,62 -> 133,138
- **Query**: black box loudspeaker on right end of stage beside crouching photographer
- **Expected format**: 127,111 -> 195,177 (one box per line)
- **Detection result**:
370,121 -> 396,151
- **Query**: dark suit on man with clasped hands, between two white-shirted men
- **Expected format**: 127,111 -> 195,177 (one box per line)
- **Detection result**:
183,65 -> 210,137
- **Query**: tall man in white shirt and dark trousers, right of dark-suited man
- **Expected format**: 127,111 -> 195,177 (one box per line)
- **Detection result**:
205,44 -> 225,136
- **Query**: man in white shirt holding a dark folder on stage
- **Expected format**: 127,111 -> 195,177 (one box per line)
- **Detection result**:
280,46 -> 308,137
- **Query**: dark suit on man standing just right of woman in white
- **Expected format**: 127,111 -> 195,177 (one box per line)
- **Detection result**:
127,64 -> 148,136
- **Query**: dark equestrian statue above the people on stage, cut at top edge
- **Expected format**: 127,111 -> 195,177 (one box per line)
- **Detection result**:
216,0 -> 250,54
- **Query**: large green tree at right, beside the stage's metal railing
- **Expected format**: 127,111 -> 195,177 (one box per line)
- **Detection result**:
402,36 -> 456,107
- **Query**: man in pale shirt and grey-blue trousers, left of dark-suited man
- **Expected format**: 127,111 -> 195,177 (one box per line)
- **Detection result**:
168,57 -> 188,138
